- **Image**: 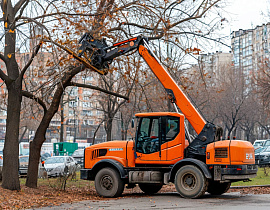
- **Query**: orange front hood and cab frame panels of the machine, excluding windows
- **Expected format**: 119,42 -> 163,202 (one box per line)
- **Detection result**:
85,112 -> 186,168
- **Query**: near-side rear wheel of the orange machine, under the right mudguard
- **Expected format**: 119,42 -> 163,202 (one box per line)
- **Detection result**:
174,165 -> 208,198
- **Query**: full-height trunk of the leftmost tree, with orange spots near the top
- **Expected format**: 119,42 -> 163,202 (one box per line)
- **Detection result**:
2,1 -> 22,190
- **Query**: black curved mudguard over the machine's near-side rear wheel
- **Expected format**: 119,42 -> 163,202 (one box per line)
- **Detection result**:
169,158 -> 212,182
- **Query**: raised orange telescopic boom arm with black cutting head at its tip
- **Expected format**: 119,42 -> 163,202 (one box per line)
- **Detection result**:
79,34 -> 206,134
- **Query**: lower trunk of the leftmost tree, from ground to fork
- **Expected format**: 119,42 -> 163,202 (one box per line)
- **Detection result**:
2,82 -> 22,190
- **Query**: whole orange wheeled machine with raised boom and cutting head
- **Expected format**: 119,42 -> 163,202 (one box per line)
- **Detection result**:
79,34 -> 258,198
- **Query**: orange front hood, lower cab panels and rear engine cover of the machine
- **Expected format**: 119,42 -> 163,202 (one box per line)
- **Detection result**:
85,139 -> 255,169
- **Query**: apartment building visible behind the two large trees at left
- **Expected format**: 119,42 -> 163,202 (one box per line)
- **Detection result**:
0,51 -> 106,143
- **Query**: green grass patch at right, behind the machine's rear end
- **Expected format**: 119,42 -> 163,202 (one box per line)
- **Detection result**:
232,167 -> 270,186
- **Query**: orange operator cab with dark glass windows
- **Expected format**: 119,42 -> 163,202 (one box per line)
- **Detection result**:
135,112 -> 185,164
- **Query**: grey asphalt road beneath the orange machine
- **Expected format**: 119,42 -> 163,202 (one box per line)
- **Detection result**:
34,193 -> 270,210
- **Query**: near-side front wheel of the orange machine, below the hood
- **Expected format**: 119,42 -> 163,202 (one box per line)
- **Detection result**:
95,168 -> 125,198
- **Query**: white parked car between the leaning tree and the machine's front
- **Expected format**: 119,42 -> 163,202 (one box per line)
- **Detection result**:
44,156 -> 77,177
